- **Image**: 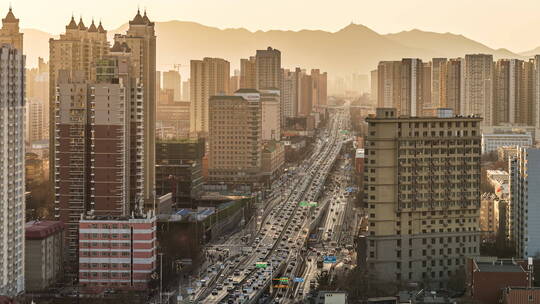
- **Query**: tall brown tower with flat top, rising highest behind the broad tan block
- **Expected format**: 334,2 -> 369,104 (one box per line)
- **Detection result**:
255,47 -> 281,89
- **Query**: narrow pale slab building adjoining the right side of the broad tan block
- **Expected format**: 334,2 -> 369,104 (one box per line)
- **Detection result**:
259,89 -> 281,140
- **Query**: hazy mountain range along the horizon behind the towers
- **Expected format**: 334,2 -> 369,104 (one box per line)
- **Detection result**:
23,21 -> 540,76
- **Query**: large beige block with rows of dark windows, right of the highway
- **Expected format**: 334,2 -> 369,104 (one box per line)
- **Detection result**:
364,108 -> 481,285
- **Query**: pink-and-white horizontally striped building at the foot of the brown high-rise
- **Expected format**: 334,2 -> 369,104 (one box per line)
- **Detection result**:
79,211 -> 157,293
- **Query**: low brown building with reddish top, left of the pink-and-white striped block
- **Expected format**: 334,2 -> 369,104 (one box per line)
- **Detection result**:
24,221 -> 65,292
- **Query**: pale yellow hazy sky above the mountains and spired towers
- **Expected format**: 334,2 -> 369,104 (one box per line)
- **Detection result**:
9,0 -> 540,52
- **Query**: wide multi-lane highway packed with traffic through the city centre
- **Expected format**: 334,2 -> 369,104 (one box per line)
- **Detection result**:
186,111 -> 347,303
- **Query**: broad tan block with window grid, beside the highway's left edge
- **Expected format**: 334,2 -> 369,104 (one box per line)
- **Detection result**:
208,89 -> 263,184
